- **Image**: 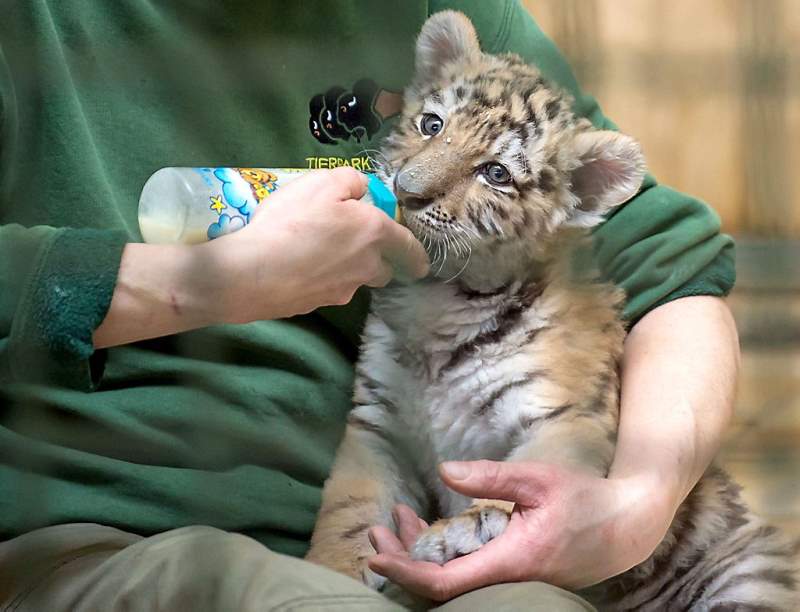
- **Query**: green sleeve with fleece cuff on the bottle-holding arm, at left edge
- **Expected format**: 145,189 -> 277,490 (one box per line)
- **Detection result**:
0,48 -> 127,391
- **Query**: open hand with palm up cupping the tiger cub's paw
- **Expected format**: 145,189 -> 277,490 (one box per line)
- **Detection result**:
369,461 -> 677,601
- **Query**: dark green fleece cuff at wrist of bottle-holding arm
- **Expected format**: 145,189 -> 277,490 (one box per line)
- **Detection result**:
9,228 -> 128,391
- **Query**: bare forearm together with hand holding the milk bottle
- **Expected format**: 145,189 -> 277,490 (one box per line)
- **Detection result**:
94,168 -> 428,348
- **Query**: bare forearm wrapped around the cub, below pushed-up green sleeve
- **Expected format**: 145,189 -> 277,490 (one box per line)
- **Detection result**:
610,296 -> 739,513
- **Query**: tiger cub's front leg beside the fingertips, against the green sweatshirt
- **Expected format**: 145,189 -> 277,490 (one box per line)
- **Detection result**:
306,416 -> 424,588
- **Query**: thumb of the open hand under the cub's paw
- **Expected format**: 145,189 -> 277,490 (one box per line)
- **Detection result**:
439,461 -> 544,506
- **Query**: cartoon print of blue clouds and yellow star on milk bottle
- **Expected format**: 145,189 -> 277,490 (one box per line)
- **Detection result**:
194,168 -> 305,240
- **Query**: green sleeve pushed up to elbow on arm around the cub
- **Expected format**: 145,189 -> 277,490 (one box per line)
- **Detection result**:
429,0 -> 736,324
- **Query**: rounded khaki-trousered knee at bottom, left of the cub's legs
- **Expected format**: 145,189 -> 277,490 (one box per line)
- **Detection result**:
106,527 -> 398,612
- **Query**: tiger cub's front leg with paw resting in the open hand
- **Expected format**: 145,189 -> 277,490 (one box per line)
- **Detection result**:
411,395 -> 616,565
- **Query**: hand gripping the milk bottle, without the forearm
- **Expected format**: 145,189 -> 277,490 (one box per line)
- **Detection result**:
206,167 -> 428,323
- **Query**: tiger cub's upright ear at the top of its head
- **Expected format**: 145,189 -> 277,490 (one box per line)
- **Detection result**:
416,11 -> 481,84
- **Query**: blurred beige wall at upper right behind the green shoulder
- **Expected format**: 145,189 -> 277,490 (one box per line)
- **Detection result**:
525,0 -> 800,238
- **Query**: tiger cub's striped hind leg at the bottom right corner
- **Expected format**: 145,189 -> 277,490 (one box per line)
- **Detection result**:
580,465 -> 800,612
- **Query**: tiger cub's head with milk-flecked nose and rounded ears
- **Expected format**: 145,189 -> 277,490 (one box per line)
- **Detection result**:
381,11 -> 645,288
